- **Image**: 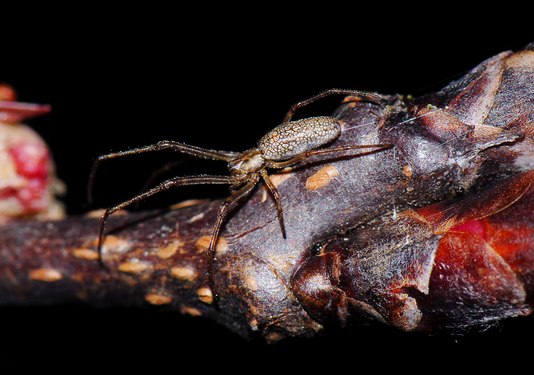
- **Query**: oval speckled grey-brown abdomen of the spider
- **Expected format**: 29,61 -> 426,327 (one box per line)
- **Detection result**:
258,116 -> 341,161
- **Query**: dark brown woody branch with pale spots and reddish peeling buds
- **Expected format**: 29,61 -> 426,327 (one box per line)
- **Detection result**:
0,44 -> 534,341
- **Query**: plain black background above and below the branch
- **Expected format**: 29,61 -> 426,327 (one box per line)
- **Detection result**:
0,4 -> 534,373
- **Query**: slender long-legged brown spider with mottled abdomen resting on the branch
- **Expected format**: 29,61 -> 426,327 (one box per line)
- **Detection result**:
88,89 -> 396,298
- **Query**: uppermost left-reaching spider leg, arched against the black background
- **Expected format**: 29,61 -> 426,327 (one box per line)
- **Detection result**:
87,141 -> 239,205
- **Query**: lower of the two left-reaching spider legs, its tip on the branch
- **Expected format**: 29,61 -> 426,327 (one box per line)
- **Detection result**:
97,176 -> 235,266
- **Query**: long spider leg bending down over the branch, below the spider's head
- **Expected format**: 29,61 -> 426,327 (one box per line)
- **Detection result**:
208,175 -> 259,303
